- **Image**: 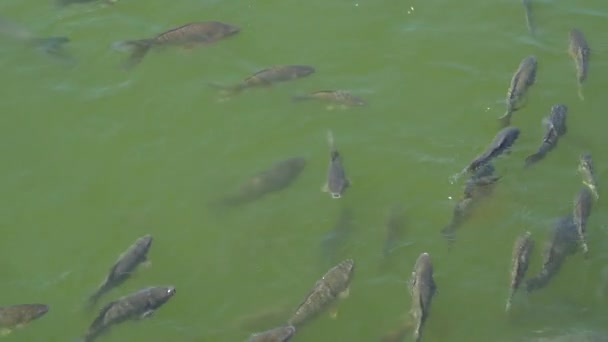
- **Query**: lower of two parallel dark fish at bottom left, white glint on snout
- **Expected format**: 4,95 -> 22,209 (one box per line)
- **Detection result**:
82,286 -> 176,342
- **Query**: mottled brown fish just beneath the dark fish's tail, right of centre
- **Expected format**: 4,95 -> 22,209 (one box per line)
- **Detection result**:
441,163 -> 500,243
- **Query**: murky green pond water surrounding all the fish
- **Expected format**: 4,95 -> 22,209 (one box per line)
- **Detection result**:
0,0 -> 608,342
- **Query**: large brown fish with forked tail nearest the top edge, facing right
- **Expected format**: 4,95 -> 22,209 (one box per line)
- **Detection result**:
112,20 -> 241,69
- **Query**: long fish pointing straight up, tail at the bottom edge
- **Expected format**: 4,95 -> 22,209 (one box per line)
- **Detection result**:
410,252 -> 437,342
